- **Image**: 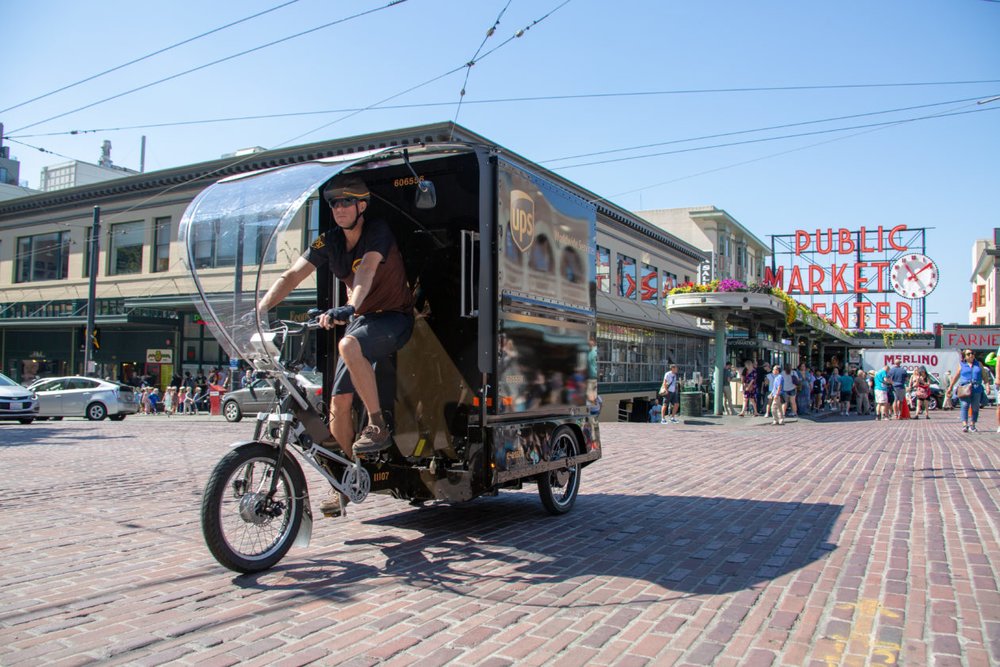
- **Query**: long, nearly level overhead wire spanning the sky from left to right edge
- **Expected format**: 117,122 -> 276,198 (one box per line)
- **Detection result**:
8,79 -> 1000,140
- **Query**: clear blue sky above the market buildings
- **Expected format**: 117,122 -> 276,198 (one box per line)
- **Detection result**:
0,0 -> 1000,323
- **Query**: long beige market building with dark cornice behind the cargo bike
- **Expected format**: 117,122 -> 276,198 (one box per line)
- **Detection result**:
0,123 -> 712,415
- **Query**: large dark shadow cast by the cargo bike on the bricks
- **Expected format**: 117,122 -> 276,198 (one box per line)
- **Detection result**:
235,493 -> 842,606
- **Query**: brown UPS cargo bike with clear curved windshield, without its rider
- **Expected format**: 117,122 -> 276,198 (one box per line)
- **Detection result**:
179,142 -> 601,572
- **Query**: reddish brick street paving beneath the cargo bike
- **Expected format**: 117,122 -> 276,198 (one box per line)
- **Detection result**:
0,411 -> 1000,667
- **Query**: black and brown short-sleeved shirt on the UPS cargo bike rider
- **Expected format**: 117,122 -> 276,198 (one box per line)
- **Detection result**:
302,218 -> 413,315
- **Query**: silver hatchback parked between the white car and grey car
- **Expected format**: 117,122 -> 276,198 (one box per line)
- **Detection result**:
29,376 -> 139,421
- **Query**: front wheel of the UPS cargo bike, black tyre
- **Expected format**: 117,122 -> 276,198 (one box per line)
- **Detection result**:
201,442 -> 306,573
